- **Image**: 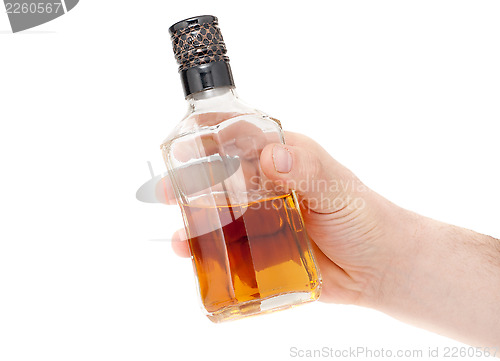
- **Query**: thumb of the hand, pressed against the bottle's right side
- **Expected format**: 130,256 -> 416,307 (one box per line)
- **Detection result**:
260,142 -> 362,213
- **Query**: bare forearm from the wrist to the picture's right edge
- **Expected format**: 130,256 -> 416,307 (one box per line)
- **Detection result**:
368,210 -> 500,353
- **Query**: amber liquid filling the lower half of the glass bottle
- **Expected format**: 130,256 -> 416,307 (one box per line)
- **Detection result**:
181,194 -> 320,322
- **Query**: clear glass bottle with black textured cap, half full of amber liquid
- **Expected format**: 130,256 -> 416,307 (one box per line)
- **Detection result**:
161,15 -> 321,322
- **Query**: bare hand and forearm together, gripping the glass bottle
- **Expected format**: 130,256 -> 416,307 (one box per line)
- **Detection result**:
172,132 -> 500,348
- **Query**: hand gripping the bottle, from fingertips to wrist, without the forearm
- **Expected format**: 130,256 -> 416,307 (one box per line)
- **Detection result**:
172,132 -> 414,305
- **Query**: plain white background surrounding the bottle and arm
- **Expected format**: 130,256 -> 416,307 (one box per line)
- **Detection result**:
0,0 -> 500,361
